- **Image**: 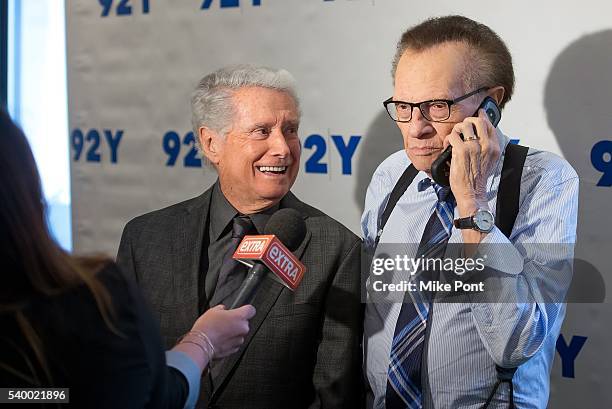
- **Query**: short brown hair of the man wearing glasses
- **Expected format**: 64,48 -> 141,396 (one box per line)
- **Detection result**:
391,16 -> 514,108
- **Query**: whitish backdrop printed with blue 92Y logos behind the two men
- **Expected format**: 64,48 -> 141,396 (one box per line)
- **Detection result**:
66,0 -> 612,408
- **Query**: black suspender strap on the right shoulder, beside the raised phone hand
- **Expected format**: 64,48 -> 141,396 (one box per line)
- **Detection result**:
495,143 -> 529,237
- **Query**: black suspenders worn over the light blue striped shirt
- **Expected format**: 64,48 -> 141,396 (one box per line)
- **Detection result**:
376,143 -> 529,409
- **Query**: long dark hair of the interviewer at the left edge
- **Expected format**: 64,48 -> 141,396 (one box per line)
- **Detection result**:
0,110 -> 116,386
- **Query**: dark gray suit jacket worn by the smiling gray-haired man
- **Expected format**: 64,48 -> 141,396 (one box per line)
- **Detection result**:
117,189 -> 362,409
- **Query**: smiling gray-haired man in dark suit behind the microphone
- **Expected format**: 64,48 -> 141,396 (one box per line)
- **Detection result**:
117,66 -> 362,409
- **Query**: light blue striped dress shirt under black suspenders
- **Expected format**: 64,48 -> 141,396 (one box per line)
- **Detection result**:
361,133 -> 578,409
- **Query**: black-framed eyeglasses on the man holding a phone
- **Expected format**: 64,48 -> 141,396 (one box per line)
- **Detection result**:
383,87 -> 487,122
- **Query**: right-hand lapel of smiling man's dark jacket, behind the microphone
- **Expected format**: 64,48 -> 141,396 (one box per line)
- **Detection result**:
211,192 -> 312,399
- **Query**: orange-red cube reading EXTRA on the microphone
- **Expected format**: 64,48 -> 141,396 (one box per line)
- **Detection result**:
233,234 -> 306,291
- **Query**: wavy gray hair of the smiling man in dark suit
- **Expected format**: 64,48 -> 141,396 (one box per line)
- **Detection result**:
191,64 -> 299,152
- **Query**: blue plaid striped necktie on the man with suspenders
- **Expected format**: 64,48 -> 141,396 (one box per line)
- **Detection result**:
385,178 -> 455,409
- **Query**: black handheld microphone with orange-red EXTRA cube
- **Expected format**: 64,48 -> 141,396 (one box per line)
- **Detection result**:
230,209 -> 306,309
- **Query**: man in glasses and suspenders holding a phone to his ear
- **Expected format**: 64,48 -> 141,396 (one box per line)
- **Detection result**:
362,16 -> 578,409
